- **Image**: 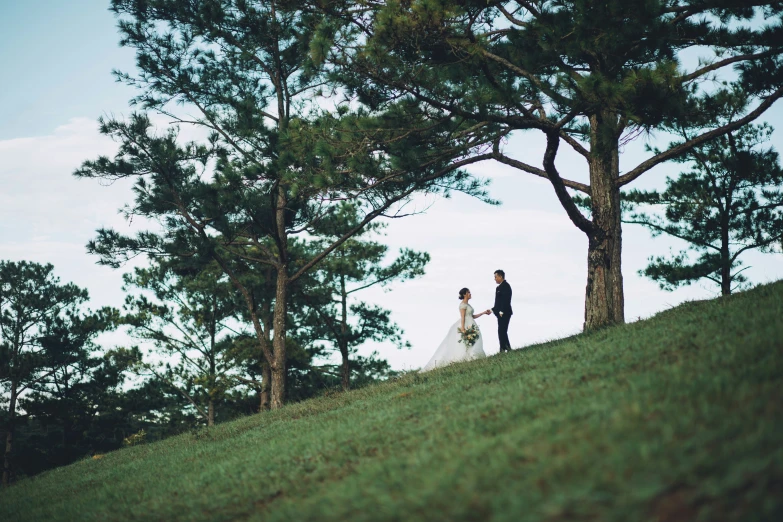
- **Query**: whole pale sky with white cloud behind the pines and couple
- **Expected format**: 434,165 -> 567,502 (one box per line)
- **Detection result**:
0,0 -> 783,369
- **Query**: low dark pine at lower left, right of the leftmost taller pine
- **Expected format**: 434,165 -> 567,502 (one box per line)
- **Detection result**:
14,344 -> 139,477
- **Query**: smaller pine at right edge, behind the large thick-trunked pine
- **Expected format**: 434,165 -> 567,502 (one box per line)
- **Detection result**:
623,119 -> 783,295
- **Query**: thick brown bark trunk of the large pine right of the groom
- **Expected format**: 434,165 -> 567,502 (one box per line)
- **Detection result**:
584,114 -> 625,330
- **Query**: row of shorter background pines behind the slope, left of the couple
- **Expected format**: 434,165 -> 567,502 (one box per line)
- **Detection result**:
0,209 -> 429,484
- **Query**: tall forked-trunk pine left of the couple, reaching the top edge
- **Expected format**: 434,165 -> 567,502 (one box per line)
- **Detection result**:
81,0 -> 496,408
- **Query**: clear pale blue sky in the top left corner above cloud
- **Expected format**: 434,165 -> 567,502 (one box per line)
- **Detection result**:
0,0 -> 134,139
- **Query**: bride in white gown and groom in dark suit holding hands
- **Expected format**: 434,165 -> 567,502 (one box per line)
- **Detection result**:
422,270 -> 513,372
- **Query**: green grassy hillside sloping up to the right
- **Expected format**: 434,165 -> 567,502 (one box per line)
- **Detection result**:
0,282 -> 783,521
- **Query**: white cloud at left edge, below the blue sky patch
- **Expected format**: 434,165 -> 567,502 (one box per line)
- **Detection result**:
0,118 -> 142,308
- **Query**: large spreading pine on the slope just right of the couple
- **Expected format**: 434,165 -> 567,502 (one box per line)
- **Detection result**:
322,0 -> 783,329
